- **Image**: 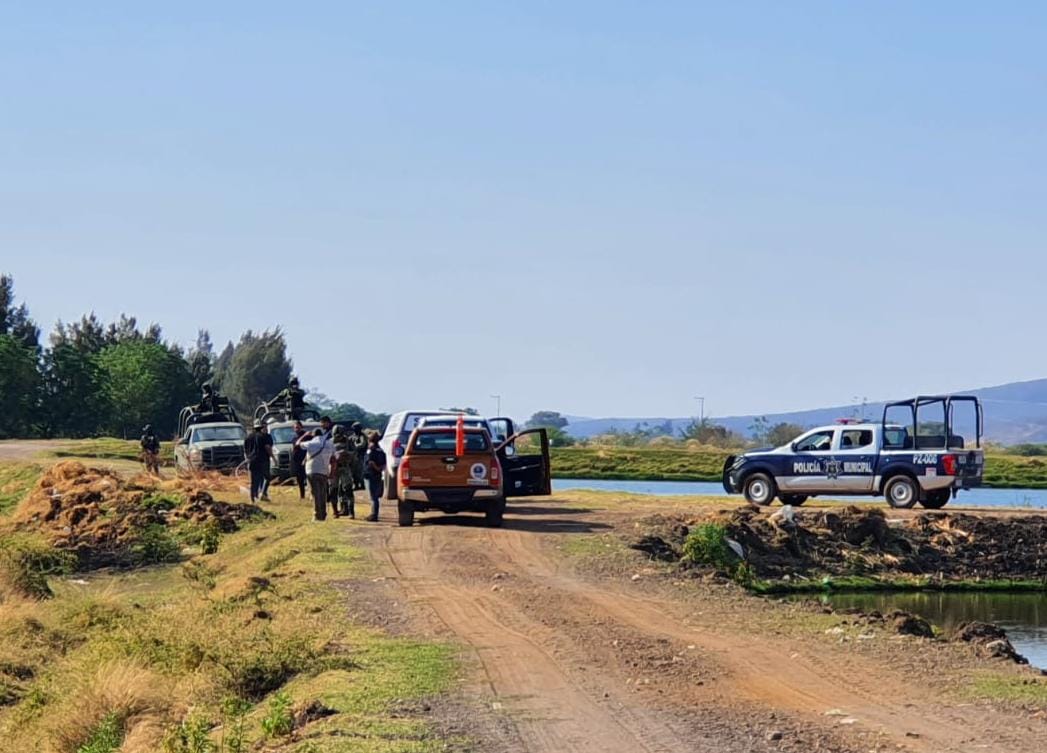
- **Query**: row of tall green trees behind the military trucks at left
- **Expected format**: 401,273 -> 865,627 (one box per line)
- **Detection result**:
0,275 -> 387,439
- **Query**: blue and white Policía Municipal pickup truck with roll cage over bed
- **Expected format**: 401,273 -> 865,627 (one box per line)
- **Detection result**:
723,395 -> 985,510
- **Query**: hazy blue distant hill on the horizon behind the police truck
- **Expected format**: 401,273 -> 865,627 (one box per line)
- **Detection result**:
566,379 -> 1047,445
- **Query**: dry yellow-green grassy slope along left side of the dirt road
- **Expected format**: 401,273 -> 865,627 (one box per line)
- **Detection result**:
0,454 -> 454,753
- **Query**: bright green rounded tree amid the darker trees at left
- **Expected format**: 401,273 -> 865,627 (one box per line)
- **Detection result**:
97,339 -> 197,437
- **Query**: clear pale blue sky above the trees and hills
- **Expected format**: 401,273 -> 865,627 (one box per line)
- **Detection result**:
0,2 -> 1047,416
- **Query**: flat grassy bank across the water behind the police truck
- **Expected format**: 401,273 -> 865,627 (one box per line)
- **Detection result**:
553,447 -> 1047,489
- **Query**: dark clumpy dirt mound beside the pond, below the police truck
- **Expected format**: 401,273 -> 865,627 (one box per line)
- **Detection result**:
632,506 -> 1047,580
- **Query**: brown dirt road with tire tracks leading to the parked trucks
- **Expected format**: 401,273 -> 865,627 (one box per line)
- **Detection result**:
361,499 -> 1047,753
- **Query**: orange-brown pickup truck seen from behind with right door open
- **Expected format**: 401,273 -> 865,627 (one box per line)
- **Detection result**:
397,426 -> 552,527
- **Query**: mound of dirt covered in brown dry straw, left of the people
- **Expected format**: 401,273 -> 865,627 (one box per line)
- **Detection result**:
12,461 -> 265,570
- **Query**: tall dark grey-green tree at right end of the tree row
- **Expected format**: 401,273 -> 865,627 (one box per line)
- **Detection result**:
215,327 -> 292,416
